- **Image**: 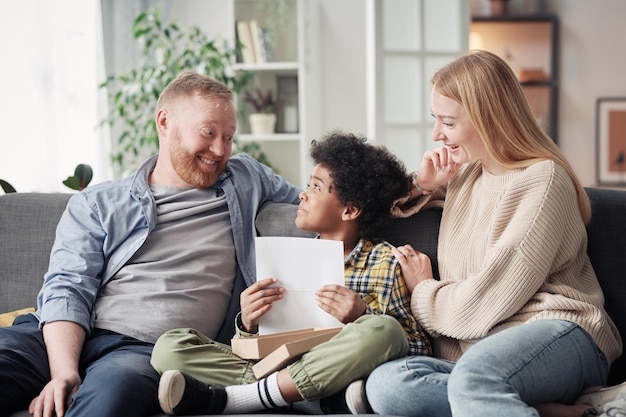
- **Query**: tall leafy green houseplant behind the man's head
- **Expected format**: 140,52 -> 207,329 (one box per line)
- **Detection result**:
100,7 -> 271,172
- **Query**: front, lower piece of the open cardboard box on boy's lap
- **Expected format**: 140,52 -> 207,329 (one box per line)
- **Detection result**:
252,327 -> 341,379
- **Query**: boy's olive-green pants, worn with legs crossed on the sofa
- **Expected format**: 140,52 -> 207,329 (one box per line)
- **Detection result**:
151,314 -> 408,401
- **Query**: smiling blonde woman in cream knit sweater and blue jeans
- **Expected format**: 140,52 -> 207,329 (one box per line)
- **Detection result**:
366,51 -> 622,417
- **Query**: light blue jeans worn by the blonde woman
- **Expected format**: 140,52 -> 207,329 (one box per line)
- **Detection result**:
366,320 -> 608,417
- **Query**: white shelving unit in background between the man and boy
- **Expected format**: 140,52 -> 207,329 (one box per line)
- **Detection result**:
229,0 -> 320,186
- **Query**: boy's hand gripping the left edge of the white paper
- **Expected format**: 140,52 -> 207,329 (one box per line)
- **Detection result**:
239,278 -> 285,333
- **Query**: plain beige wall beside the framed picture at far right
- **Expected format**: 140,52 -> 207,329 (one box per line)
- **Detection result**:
548,0 -> 626,185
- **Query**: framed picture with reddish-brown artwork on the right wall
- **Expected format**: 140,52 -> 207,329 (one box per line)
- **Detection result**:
596,97 -> 626,186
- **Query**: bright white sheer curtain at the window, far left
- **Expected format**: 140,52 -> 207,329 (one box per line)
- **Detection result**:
0,0 -> 112,192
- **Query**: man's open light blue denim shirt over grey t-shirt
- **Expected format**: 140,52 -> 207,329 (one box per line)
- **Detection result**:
36,154 -> 301,342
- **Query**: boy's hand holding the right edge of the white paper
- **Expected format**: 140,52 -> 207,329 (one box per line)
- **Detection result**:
315,285 -> 367,324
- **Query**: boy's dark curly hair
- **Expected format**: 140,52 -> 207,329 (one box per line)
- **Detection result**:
310,131 -> 410,238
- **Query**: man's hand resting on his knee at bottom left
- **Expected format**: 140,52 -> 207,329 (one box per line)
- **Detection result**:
28,373 -> 82,417
